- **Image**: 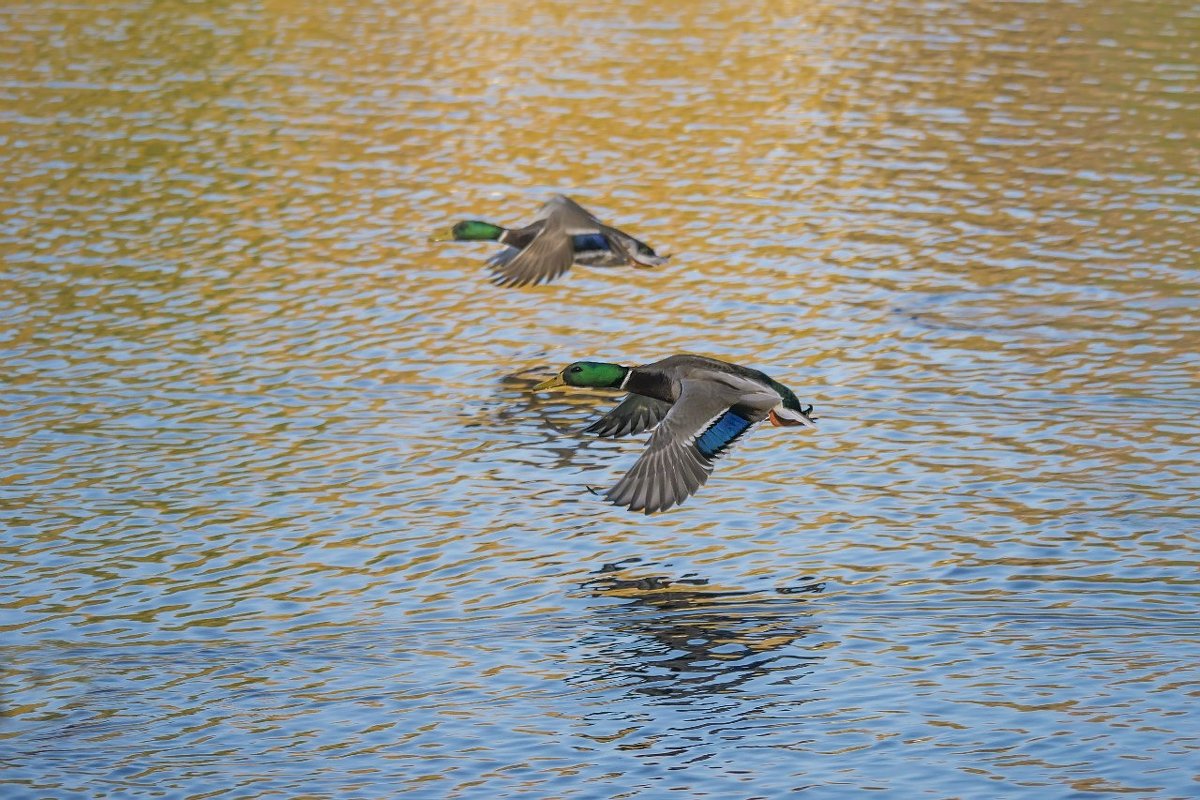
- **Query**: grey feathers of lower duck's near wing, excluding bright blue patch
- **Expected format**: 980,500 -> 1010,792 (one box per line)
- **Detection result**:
605,374 -> 779,513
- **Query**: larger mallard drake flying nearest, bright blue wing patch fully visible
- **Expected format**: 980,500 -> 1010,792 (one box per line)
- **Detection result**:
533,354 -> 816,513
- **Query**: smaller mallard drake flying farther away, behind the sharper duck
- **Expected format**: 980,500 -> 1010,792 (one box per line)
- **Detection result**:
436,194 -> 670,287
